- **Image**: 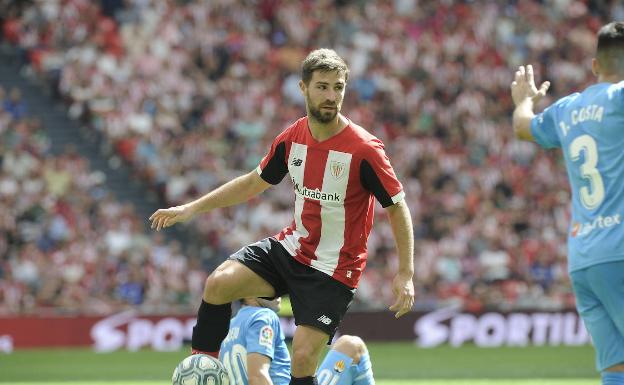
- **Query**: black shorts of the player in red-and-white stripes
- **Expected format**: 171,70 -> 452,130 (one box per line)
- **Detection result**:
230,238 -> 355,344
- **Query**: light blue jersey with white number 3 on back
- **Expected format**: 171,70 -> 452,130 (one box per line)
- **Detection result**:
531,81 -> 624,272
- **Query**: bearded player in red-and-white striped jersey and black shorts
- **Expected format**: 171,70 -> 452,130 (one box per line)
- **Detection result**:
150,49 -> 414,385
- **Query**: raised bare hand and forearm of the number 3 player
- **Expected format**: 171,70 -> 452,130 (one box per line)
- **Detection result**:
511,64 -> 550,141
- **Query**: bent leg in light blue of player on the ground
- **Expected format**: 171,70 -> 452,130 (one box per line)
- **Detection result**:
317,335 -> 375,385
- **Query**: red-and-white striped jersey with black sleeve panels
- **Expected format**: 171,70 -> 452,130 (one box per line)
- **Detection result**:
257,117 -> 405,288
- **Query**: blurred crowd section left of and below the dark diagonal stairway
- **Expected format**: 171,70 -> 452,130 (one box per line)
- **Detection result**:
0,83 -> 207,316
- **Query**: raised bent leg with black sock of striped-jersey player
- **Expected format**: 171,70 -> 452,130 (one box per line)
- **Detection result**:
191,239 -> 285,356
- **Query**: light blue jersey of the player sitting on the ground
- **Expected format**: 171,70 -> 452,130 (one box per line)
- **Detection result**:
219,306 -> 290,385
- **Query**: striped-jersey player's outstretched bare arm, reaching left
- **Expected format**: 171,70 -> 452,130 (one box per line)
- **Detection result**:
149,170 -> 271,231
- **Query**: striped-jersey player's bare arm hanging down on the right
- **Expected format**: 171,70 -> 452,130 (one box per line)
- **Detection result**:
386,200 -> 414,318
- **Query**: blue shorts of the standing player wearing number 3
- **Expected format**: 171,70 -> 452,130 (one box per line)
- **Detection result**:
570,261 -> 624,371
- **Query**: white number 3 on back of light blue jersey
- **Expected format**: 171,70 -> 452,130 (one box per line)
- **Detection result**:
570,135 -> 604,210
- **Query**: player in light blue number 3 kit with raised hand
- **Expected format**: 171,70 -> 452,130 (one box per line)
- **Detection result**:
511,22 -> 624,385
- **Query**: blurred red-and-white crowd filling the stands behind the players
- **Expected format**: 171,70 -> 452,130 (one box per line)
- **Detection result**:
0,0 -> 624,311
